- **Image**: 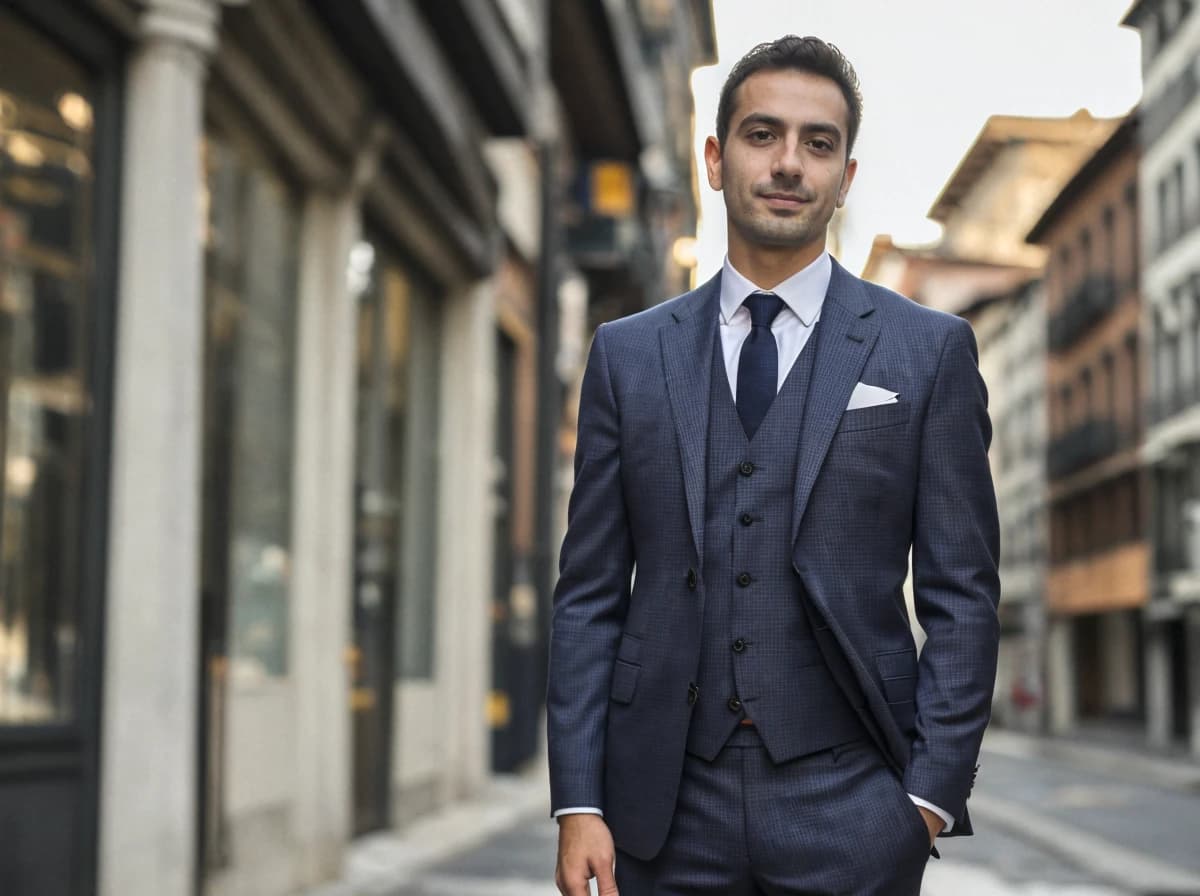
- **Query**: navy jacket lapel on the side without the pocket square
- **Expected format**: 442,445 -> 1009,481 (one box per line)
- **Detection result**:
659,273 -> 721,558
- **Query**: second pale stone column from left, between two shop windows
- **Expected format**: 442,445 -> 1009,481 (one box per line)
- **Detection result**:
289,193 -> 360,885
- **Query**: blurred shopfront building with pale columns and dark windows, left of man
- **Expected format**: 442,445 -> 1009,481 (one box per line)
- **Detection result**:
0,0 -> 713,896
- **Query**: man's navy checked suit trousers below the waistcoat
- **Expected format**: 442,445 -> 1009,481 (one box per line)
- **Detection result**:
617,727 -> 930,896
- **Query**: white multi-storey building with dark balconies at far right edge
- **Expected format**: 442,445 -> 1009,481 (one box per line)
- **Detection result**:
1122,0 -> 1200,756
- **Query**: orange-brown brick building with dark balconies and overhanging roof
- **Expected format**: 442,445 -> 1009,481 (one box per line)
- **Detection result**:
1028,115 -> 1150,733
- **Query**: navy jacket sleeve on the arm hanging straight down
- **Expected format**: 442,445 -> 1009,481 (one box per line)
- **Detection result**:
546,326 -> 634,812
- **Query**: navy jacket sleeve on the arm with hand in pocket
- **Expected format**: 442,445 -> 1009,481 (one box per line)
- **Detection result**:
905,319 -> 1000,834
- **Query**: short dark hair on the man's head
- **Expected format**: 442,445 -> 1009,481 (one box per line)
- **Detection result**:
716,35 -> 863,158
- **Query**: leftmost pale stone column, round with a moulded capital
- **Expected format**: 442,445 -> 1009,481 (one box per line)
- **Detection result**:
100,0 -> 218,896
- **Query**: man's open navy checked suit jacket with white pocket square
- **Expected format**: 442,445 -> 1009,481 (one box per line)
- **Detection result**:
547,263 -> 1000,859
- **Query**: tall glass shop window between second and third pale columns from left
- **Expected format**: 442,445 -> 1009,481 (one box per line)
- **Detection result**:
350,236 -> 440,832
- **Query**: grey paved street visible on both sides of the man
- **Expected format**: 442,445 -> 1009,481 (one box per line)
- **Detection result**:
391,733 -> 1200,896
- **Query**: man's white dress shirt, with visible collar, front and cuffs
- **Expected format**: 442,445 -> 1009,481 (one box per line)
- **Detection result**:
554,252 -> 954,832
